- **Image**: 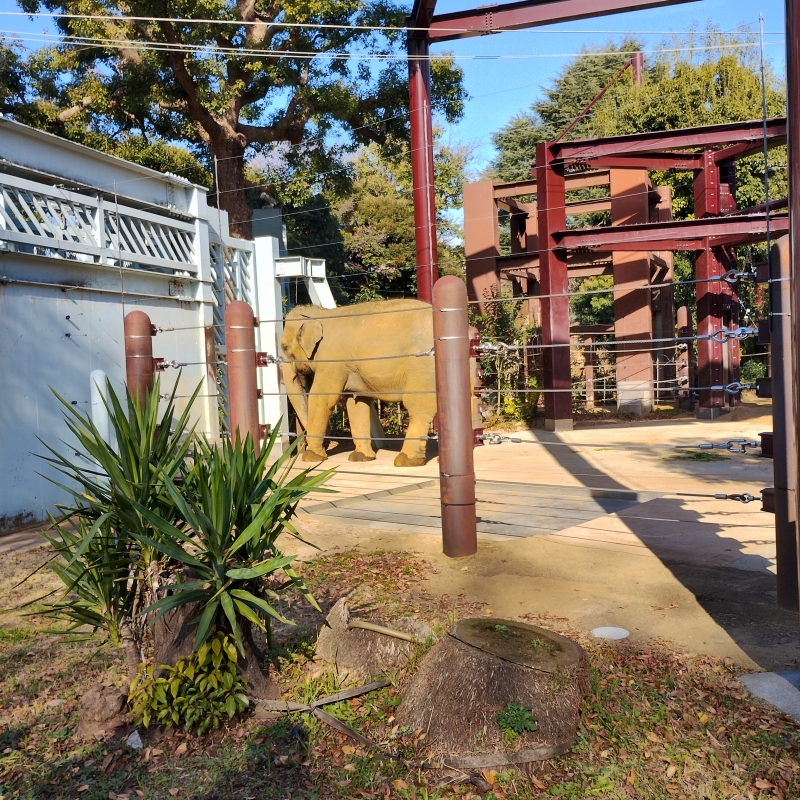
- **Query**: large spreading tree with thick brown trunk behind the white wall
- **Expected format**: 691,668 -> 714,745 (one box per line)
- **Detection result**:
20,0 -> 464,236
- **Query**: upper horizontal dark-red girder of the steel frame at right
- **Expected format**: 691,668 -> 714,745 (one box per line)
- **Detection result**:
548,117 -> 786,166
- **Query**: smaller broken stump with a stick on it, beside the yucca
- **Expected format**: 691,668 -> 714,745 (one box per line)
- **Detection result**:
316,598 -> 433,682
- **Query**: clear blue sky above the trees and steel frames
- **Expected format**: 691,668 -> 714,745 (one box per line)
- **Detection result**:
0,0 -> 784,171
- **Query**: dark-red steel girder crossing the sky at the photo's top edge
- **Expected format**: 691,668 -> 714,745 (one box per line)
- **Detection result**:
424,0 -> 696,42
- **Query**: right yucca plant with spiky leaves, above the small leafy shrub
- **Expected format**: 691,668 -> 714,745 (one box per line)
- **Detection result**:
132,426 -> 332,655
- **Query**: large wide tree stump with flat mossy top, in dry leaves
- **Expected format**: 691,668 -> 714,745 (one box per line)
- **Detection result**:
395,619 -> 589,769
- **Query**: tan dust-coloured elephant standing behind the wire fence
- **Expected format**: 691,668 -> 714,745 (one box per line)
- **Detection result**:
280,299 -> 436,467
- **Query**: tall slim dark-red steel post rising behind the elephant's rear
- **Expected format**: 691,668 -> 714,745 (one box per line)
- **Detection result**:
408,38 -> 439,303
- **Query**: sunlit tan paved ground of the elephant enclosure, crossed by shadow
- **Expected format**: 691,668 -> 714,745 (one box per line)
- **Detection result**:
301,405 -> 775,572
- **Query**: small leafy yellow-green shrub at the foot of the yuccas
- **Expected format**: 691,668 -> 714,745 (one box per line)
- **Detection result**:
128,633 -> 249,735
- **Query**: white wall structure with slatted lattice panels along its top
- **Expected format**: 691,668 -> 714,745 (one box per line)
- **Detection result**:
0,118 -> 332,533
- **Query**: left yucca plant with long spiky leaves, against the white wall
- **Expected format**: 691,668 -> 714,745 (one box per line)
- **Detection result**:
36,381 -> 199,671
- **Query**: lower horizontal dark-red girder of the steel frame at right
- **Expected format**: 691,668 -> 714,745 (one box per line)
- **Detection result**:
553,214 -> 789,251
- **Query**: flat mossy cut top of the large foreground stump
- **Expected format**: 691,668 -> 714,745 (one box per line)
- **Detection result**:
450,619 -> 581,672
